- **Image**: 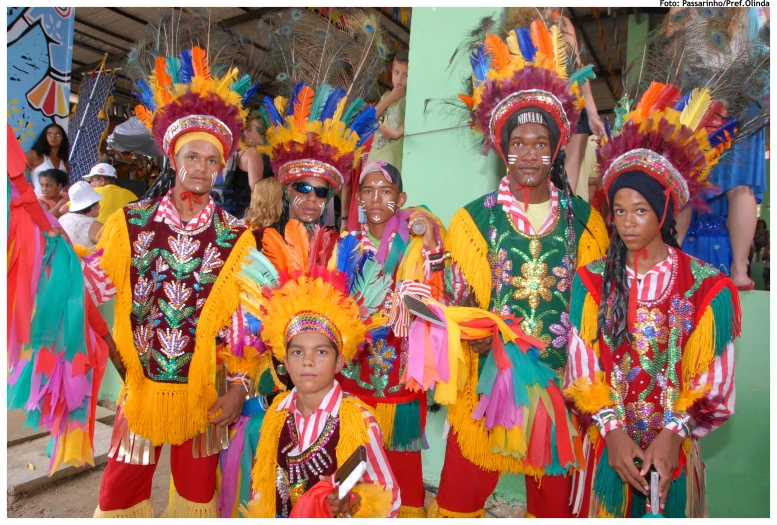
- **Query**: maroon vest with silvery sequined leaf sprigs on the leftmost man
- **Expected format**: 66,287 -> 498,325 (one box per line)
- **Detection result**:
124,198 -> 245,383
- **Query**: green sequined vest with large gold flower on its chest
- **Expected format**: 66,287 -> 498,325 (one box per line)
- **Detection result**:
464,192 -> 591,372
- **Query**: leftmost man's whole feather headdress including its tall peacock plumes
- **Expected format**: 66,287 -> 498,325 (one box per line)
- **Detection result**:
127,12 -> 257,161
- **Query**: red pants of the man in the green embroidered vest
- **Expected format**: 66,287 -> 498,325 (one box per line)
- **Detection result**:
437,431 -> 572,518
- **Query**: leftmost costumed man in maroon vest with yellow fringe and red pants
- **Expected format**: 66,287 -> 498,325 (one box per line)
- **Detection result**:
85,46 -> 257,517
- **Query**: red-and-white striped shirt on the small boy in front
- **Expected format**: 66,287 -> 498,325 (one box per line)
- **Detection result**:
276,380 -> 402,518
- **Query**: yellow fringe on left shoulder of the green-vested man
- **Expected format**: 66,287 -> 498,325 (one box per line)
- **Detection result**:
446,208 -> 491,307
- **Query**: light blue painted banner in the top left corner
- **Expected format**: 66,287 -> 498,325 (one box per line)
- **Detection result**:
6,7 -> 75,145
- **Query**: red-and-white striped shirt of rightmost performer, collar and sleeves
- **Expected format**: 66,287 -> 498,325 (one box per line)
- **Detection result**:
564,248 -> 736,438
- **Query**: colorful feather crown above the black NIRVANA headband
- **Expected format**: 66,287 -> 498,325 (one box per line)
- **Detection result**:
459,20 -> 594,162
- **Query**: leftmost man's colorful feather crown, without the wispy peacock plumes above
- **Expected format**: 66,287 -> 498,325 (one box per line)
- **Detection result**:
134,46 -> 258,160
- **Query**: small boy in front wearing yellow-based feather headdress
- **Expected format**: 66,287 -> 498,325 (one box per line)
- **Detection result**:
239,221 -> 401,518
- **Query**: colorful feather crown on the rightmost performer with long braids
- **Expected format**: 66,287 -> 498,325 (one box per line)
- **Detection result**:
597,82 -> 738,211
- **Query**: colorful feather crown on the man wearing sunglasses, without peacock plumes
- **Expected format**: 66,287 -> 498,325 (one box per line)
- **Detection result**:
260,82 -> 378,193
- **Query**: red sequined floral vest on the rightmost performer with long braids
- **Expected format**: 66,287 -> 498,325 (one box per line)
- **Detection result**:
578,249 -> 727,449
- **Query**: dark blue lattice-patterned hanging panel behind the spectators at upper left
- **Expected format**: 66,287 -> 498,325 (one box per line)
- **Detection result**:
67,71 -> 116,184
